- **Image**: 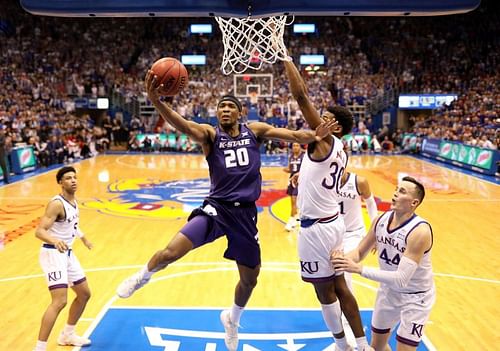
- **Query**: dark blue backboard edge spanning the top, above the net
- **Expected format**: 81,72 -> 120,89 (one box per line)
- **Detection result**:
20,0 -> 480,17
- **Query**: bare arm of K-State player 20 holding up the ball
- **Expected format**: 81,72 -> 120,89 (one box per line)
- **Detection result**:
145,70 -> 215,144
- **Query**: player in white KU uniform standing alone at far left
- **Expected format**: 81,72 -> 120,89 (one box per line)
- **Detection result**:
34,167 -> 92,351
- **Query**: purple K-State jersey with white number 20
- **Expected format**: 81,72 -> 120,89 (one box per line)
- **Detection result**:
207,124 -> 262,202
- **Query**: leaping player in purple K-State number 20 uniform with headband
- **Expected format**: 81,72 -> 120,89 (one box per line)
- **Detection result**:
117,71 -> 337,350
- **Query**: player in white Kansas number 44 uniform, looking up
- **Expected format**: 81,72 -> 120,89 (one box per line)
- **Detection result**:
332,177 -> 436,351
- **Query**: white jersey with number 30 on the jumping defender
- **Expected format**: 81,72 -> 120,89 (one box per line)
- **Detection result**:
297,137 -> 347,219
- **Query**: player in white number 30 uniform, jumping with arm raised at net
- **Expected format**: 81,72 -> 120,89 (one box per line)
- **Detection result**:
284,61 -> 371,351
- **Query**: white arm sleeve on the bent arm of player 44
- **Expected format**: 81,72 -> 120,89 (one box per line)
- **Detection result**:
361,256 -> 418,288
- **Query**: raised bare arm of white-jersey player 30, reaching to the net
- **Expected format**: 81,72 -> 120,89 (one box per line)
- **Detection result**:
284,61 -> 322,129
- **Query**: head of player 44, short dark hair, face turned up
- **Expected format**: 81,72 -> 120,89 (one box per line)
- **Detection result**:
391,176 -> 425,212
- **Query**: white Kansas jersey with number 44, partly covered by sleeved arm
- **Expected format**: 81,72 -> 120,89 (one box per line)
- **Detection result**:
375,211 -> 434,293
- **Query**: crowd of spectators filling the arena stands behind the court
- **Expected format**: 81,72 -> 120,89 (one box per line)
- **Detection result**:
0,0 -> 500,174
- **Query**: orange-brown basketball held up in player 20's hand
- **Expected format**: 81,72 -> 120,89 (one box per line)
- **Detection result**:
151,57 -> 188,96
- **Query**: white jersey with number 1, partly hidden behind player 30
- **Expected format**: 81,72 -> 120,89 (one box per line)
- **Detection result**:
337,173 -> 366,232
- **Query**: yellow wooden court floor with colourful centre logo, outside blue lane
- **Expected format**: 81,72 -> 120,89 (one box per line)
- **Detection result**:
0,155 -> 500,351
